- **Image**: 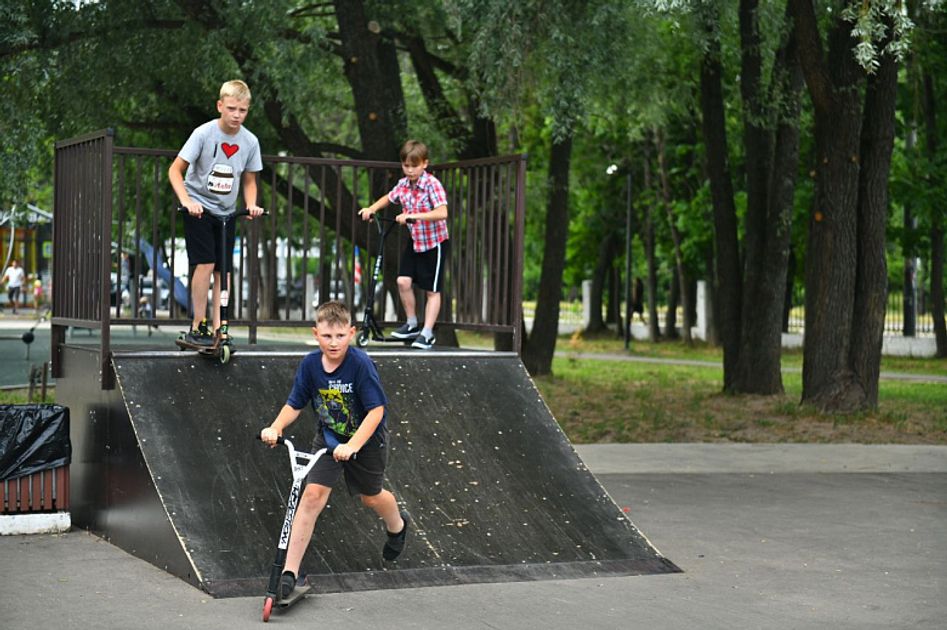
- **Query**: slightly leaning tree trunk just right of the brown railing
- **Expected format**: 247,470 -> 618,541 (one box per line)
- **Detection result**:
523,135 -> 572,376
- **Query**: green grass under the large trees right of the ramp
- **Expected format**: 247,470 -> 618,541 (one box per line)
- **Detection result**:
520,335 -> 947,444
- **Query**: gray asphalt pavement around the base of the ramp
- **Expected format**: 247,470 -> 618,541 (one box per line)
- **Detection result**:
0,444 -> 947,630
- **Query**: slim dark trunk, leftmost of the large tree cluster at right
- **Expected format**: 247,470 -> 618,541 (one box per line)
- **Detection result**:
700,6 -> 743,391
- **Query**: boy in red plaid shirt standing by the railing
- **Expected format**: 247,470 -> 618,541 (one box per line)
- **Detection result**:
359,140 -> 450,350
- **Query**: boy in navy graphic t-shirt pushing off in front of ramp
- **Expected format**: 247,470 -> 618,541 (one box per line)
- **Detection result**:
260,302 -> 410,598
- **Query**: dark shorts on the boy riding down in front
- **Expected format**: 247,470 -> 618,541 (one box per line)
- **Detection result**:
306,428 -> 388,497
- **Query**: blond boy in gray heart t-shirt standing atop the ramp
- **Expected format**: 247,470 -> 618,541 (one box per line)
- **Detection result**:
168,81 -> 263,346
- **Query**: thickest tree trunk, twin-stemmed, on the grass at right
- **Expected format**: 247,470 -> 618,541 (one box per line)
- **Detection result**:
790,0 -> 893,412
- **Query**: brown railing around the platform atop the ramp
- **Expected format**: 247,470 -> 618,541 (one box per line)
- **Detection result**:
52,130 -> 526,387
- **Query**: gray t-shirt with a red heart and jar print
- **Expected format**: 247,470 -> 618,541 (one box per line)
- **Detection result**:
178,119 -> 263,216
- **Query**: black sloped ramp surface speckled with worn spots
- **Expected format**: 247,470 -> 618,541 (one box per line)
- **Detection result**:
114,352 -> 678,596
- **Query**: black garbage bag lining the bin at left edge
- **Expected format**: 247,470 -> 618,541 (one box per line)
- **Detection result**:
0,405 -> 72,480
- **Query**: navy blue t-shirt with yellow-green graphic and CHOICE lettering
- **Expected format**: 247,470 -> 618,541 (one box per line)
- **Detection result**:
286,348 -> 388,438
